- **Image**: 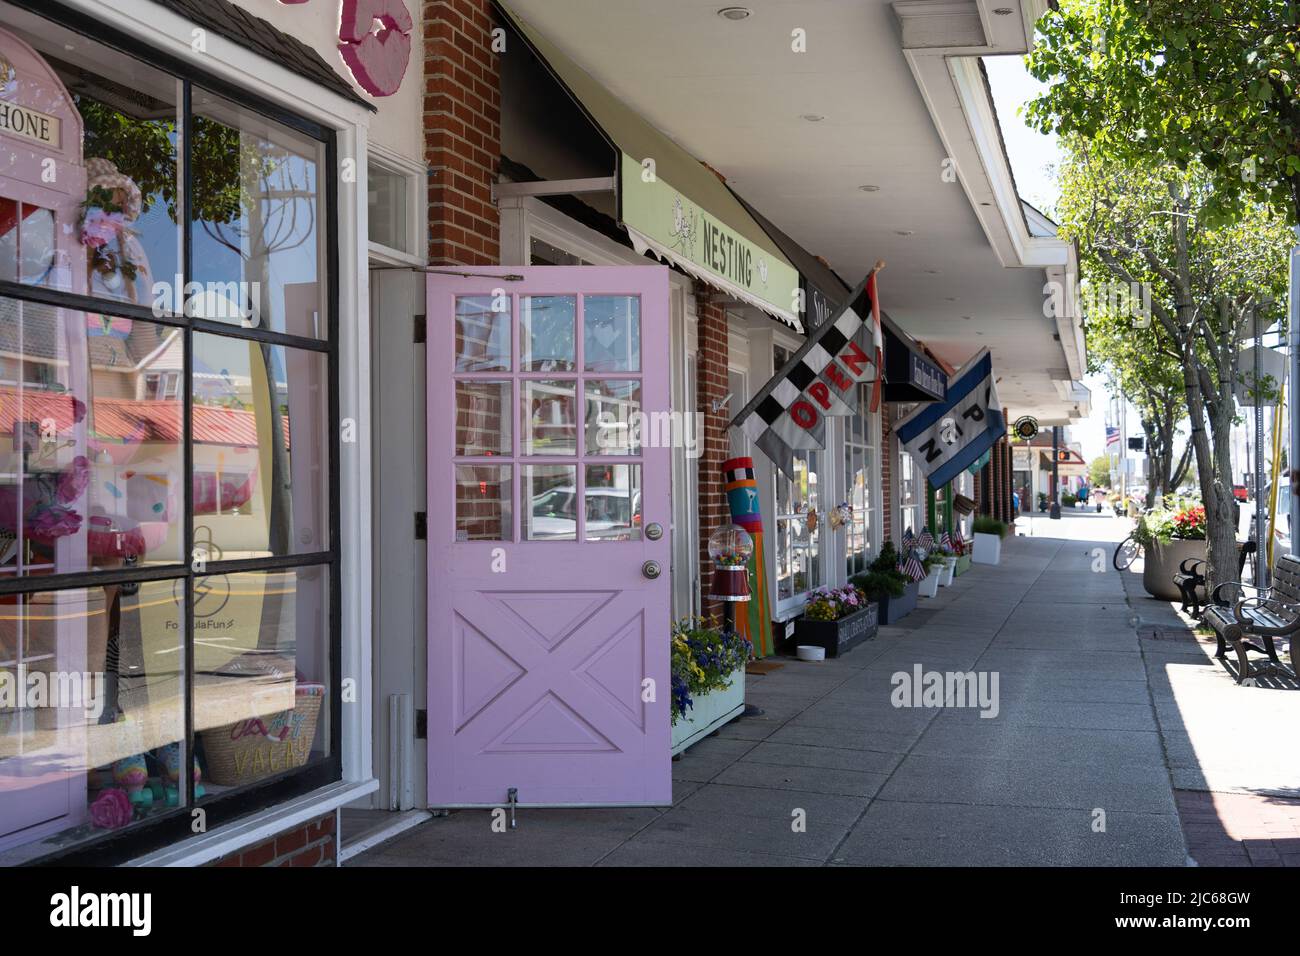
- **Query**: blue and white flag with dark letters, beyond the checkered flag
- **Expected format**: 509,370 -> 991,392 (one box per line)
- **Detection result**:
893,349 -> 1006,488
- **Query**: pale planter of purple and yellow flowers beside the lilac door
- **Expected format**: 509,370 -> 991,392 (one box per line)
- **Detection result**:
671,618 -> 753,754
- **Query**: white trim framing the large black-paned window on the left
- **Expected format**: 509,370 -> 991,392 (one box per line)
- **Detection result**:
79,0 -> 377,865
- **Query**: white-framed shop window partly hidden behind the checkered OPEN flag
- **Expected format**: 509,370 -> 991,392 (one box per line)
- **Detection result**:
774,346 -> 822,602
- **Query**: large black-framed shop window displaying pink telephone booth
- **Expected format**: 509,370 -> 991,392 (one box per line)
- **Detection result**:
0,3 -> 339,862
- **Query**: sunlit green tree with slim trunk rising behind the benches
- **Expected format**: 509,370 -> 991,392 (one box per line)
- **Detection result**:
1057,135 -> 1290,583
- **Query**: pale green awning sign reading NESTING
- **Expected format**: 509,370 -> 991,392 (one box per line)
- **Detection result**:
620,153 -> 800,313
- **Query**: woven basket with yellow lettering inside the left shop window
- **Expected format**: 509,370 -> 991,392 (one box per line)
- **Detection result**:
202,684 -> 325,786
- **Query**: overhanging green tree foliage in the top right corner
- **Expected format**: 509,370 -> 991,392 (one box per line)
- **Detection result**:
1027,0 -> 1300,225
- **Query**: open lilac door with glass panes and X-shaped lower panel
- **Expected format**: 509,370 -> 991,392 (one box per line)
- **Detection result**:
428,265 -> 672,808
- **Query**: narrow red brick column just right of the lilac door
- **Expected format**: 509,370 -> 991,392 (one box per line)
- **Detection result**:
696,282 -> 733,618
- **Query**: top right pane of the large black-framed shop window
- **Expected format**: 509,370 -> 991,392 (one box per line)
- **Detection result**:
186,88 -> 329,338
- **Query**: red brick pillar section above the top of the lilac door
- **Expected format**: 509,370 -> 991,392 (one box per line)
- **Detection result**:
424,0 -> 501,265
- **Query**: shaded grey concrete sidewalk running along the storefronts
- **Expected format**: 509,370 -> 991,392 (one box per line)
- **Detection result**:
348,516 -> 1187,866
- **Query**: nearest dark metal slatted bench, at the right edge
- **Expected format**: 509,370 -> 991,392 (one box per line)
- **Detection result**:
1203,554 -> 1300,684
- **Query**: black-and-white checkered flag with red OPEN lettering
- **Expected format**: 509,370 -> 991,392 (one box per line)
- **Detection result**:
731,261 -> 884,479
